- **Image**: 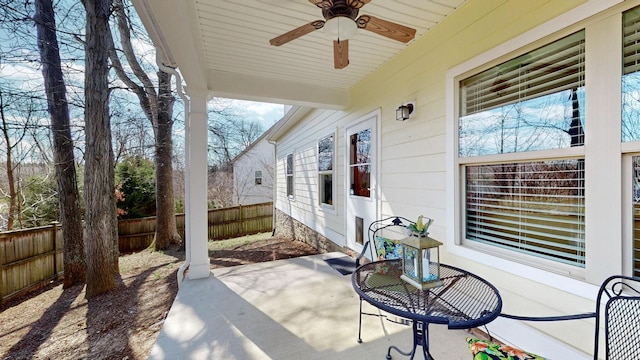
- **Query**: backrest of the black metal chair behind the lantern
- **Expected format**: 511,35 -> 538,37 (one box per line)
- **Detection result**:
367,216 -> 415,261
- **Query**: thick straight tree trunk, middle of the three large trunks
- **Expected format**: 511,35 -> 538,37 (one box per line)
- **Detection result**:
84,0 -> 118,298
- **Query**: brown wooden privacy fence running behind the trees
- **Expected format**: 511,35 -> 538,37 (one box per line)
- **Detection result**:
0,202 -> 273,302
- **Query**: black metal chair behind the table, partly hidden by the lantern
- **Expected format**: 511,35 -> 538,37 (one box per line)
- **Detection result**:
356,216 -> 415,343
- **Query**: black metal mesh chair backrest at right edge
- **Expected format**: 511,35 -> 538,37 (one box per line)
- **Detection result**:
594,275 -> 640,360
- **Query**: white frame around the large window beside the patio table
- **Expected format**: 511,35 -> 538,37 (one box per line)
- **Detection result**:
446,0 -> 631,297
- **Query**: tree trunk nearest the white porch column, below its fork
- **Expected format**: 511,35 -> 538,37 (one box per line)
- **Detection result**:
155,71 -> 181,250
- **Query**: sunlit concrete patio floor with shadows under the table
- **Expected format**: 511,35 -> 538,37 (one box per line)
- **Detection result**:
149,253 -> 471,360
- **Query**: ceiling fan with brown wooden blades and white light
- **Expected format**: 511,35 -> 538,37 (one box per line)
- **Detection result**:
269,0 -> 416,69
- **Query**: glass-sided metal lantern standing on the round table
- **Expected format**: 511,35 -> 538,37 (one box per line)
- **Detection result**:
400,236 -> 442,290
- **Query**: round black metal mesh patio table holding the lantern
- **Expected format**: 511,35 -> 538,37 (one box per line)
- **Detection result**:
351,260 -> 502,359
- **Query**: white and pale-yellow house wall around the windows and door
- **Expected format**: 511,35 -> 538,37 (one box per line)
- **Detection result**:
268,0 -> 640,359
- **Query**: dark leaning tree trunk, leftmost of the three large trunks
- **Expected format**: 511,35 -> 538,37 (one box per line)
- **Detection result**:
34,0 -> 87,288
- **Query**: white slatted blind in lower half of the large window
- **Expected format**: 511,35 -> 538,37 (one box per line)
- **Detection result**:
465,159 -> 585,267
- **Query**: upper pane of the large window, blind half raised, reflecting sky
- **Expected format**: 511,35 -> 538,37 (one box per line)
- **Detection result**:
458,31 -> 585,157
